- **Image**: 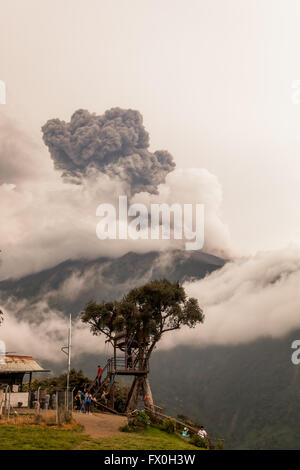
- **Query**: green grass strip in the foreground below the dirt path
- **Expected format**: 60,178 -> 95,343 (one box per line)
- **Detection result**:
0,426 -> 199,451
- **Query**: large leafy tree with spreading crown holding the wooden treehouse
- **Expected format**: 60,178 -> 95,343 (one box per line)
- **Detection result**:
81,279 -> 204,409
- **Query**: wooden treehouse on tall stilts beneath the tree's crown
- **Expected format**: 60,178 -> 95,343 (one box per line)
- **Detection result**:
89,332 -> 153,411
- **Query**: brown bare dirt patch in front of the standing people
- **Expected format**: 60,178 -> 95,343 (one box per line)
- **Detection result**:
73,411 -> 127,439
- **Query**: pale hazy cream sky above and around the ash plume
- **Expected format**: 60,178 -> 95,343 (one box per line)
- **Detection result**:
0,0 -> 300,251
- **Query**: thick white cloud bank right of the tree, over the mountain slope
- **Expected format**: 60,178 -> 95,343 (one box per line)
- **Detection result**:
163,247 -> 300,348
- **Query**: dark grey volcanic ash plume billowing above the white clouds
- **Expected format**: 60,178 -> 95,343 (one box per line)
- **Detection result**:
42,108 -> 175,194
